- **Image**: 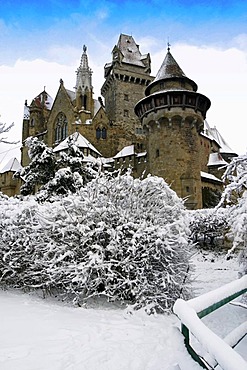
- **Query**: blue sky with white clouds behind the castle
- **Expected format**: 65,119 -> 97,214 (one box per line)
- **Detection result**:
0,0 -> 247,164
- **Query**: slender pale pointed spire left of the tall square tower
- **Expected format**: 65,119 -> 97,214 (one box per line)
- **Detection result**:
75,45 -> 94,114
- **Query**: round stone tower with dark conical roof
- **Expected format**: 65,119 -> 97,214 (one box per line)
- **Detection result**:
135,47 -> 210,209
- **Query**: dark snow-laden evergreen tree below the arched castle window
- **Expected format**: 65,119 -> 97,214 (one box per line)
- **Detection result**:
15,137 -> 96,201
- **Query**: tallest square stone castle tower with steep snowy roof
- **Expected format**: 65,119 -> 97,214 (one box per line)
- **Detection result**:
101,34 -> 153,150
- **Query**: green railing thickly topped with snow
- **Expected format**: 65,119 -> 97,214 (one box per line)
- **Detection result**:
173,275 -> 247,370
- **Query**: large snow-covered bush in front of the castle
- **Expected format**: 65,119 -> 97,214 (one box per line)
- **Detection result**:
0,173 -> 189,312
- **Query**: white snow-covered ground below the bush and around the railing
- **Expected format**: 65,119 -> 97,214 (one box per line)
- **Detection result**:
0,253 -> 247,370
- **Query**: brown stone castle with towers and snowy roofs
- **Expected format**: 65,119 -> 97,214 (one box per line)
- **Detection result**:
0,34 -> 236,209
